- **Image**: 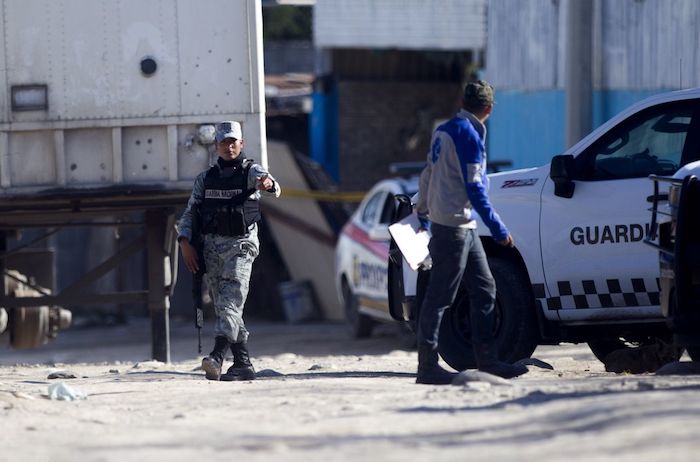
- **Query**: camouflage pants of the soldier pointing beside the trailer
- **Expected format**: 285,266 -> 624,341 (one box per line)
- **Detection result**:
204,225 -> 260,343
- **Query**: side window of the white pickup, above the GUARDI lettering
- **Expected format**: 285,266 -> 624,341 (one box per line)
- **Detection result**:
577,105 -> 693,180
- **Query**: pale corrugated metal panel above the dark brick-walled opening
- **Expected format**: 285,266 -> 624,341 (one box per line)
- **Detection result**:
314,0 -> 487,50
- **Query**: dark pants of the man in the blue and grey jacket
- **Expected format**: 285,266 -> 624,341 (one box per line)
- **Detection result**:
418,223 -> 496,349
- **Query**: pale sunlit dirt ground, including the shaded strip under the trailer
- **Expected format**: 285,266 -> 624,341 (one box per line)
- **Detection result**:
0,320 -> 700,462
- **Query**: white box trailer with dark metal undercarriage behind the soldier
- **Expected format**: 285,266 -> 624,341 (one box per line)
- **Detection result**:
0,0 -> 267,361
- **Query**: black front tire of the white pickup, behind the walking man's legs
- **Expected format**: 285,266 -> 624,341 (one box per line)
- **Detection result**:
439,258 -> 539,370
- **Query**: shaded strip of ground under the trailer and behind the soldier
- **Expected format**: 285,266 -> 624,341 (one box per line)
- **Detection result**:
0,318 -> 412,365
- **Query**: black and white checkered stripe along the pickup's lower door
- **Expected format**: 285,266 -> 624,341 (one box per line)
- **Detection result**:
532,278 -> 660,310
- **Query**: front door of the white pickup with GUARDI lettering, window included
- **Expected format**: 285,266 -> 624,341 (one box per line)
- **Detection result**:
540,101 -> 698,320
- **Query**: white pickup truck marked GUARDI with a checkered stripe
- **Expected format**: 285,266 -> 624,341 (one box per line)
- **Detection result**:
389,88 -> 700,369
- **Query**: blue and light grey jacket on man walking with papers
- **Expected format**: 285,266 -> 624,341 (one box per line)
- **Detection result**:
416,109 -> 509,241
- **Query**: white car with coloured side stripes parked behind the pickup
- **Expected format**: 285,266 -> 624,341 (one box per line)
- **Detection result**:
335,175 -> 418,338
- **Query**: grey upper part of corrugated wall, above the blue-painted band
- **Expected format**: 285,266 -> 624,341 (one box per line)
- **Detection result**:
486,0 -> 700,90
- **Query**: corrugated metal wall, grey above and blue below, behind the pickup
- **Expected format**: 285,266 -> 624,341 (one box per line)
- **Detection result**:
484,0 -> 700,168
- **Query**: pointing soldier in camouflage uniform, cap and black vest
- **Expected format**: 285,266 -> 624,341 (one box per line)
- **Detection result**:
178,121 -> 281,381
